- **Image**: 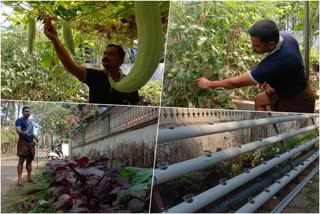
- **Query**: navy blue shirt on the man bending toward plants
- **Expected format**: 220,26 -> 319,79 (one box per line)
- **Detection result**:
250,33 -> 307,97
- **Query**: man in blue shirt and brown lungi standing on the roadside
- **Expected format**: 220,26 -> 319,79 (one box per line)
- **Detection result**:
15,106 -> 39,186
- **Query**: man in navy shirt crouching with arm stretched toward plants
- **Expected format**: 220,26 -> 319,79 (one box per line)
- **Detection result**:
195,19 -> 315,113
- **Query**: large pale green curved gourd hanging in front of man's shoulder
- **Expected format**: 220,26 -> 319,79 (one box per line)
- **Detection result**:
109,1 -> 163,93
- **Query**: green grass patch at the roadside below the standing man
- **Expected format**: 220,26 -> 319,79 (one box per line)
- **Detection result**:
1,167 -> 54,213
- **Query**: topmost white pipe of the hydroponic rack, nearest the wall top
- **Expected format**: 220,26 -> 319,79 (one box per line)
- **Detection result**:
157,114 -> 318,143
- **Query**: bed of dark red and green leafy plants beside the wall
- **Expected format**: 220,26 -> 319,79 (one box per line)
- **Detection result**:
28,157 -> 152,213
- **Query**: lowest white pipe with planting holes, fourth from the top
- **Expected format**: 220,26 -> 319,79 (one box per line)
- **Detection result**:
236,152 -> 319,213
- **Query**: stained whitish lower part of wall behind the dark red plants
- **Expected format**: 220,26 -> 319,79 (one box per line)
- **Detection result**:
72,124 -> 157,168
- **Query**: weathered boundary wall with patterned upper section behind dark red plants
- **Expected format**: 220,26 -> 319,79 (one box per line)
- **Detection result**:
71,107 -> 159,167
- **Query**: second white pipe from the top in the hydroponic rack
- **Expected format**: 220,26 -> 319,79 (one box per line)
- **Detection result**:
154,125 -> 319,185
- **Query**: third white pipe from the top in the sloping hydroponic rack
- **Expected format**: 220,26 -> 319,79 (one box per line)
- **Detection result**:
166,137 -> 319,213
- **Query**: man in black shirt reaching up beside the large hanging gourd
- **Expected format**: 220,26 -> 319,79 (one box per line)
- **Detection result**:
44,18 -> 139,105
